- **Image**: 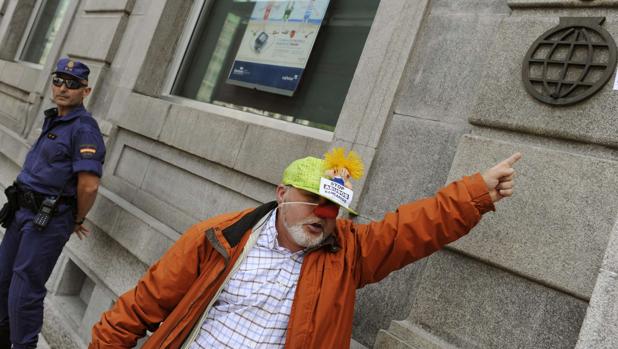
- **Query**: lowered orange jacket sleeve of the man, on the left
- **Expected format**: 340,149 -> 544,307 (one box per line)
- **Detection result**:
89,225 -> 205,349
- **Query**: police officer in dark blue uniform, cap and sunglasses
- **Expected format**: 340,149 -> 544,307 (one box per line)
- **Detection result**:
0,58 -> 105,349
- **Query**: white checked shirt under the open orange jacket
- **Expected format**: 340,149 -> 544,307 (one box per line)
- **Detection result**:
190,210 -> 304,349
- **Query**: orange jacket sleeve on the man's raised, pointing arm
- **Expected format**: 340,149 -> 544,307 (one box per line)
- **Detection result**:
353,173 -> 494,287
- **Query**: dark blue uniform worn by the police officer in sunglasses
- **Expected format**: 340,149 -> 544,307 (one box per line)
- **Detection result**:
0,60 -> 105,348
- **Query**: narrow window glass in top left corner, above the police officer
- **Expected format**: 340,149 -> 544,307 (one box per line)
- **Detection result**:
21,0 -> 69,64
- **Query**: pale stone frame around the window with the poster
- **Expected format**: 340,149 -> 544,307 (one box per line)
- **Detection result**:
152,0 -> 430,160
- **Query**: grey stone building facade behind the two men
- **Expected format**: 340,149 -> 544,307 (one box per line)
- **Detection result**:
0,0 -> 618,349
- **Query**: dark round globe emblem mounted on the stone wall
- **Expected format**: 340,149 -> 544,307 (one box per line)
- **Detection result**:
522,17 -> 616,106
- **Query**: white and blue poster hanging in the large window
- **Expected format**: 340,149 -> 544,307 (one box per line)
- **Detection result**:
227,0 -> 330,96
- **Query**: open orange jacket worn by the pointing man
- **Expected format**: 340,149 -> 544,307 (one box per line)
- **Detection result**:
89,174 -> 494,349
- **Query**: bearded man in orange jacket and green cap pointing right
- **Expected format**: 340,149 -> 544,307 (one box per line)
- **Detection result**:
89,149 -> 521,349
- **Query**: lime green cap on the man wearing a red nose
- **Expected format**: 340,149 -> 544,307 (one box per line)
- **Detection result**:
281,156 -> 358,215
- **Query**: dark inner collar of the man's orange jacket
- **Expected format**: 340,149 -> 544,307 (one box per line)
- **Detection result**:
222,201 -> 341,253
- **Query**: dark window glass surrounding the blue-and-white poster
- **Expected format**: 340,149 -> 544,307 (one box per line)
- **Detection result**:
172,0 -> 379,130
